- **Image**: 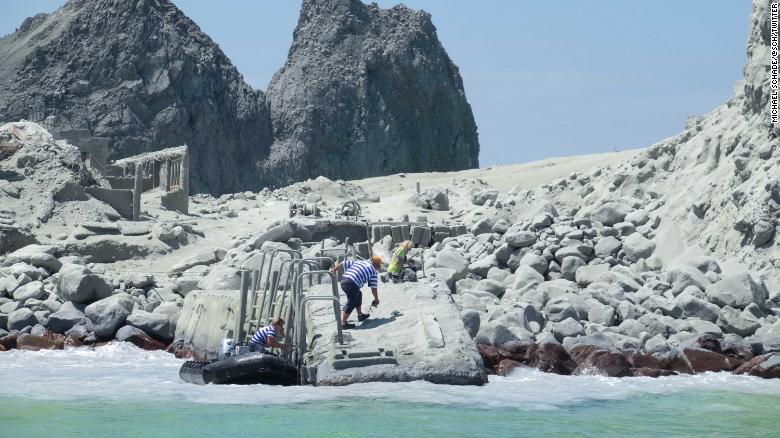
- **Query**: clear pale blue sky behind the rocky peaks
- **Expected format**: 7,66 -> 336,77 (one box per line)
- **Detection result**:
0,0 -> 751,167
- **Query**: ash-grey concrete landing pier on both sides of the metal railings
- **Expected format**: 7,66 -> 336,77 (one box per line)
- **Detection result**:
176,280 -> 487,386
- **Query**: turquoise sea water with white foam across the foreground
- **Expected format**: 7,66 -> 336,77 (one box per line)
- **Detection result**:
0,343 -> 780,437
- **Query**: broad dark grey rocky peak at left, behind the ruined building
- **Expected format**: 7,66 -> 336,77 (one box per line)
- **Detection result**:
0,0 -> 271,192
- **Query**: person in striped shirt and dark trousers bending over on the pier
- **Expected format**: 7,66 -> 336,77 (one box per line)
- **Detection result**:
330,256 -> 382,328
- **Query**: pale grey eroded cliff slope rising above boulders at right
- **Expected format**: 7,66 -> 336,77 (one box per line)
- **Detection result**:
502,0 -> 780,288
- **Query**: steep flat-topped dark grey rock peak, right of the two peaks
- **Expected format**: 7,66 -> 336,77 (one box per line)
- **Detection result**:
261,0 -> 479,183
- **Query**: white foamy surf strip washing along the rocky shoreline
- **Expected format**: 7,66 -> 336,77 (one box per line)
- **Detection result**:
0,343 -> 780,409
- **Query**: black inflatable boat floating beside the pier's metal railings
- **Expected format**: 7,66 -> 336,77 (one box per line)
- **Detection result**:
179,353 -> 298,386
